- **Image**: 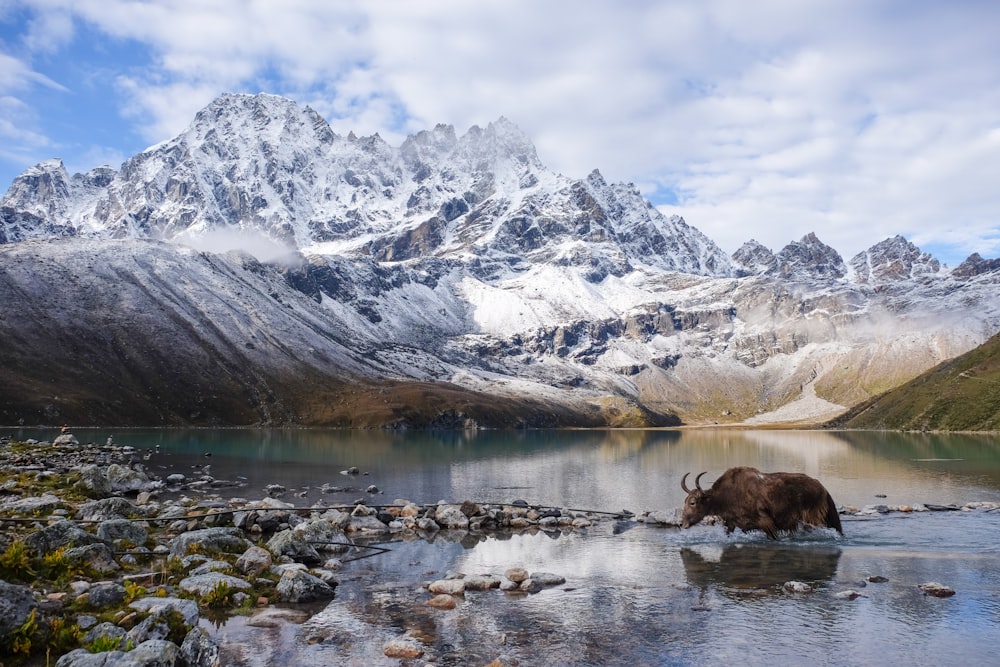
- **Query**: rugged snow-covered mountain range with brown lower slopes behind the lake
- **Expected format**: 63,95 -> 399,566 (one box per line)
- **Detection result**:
0,95 -> 1000,426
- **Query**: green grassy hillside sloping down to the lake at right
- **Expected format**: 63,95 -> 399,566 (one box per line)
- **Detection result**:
826,334 -> 1000,431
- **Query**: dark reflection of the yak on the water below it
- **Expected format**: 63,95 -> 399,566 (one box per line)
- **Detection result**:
680,543 -> 840,595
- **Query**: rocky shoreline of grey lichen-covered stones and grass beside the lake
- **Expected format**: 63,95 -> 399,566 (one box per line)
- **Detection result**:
0,434 -> 611,667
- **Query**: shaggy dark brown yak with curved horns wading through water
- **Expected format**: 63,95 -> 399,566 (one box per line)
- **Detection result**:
681,466 -> 844,540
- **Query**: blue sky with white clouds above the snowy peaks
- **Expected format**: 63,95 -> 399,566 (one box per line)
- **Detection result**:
0,0 -> 1000,265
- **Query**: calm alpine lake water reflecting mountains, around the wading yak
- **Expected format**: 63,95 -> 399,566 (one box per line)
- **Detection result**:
13,429 -> 1000,667
